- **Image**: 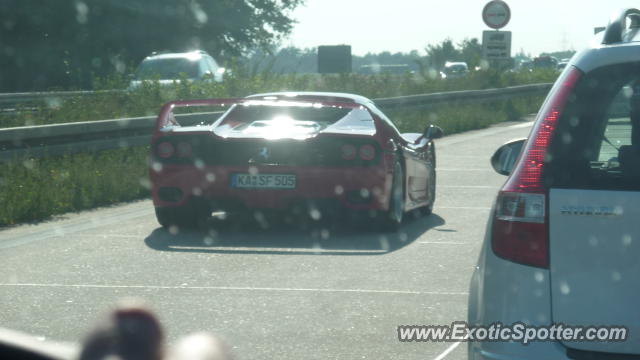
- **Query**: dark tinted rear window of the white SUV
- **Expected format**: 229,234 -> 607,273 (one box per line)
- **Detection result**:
545,63 -> 640,190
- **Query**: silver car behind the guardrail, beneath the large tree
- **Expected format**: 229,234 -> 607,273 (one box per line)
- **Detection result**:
129,50 -> 225,88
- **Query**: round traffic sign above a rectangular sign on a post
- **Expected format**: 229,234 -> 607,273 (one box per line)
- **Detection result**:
482,0 -> 511,67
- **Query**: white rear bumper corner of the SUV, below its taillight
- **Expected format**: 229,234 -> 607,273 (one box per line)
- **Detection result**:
468,214 -> 569,360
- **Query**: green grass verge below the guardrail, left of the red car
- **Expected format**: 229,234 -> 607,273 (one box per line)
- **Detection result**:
0,147 -> 149,226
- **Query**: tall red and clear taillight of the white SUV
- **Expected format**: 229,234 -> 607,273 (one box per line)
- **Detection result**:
491,67 -> 582,268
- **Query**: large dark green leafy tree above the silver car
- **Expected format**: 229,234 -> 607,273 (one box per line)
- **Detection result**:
0,0 -> 304,91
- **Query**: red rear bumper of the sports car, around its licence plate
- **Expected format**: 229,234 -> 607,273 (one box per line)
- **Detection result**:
149,161 -> 392,210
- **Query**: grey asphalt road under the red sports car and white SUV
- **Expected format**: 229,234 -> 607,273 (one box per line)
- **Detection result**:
0,119 -> 530,360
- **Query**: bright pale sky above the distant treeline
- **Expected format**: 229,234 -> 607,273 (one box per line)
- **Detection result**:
282,0 -> 640,56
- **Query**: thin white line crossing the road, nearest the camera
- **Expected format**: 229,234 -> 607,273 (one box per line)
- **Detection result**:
0,283 -> 469,296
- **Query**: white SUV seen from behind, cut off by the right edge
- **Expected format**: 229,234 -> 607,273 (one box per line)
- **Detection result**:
468,9 -> 640,360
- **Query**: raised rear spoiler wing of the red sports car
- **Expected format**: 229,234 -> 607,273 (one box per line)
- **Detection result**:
154,98 -> 365,134
